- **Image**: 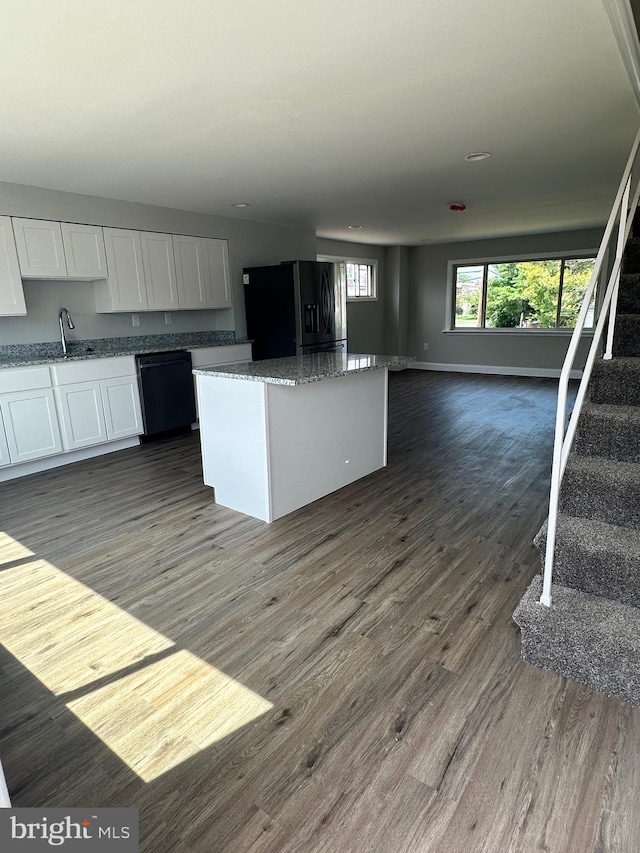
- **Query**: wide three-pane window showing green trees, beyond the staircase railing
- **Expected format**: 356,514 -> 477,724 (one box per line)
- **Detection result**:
452,255 -> 595,329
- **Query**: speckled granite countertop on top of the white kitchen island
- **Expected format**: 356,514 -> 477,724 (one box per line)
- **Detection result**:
193,352 -> 415,385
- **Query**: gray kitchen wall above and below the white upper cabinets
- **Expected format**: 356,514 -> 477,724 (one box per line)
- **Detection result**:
0,182 -> 316,344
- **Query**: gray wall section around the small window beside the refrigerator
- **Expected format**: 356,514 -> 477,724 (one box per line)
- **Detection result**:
316,238 -> 388,353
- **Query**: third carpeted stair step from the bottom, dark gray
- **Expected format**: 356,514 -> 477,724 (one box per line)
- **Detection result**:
560,453 -> 640,530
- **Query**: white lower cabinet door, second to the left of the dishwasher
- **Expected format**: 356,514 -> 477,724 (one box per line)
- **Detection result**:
55,382 -> 107,450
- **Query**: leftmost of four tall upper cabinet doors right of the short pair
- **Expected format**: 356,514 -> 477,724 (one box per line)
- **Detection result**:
103,228 -> 147,311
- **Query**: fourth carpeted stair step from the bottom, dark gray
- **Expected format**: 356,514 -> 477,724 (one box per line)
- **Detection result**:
576,403 -> 640,463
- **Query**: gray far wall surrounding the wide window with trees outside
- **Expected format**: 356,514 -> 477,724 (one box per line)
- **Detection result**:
408,229 -> 602,370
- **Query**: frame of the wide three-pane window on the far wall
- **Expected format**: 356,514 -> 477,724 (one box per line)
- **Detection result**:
443,248 -> 608,336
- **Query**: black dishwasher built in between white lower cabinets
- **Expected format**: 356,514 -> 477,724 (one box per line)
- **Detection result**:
136,350 -> 196,441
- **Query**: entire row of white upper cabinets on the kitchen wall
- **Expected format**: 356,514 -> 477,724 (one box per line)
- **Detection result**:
0,216 -> 232,316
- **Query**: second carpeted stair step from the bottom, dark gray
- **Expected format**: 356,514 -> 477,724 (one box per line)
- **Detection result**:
533,513 -> 640,607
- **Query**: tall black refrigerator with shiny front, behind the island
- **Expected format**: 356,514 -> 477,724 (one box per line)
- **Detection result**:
243,261 -> 347,361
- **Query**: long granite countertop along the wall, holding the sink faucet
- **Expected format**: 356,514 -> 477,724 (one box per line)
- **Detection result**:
0,331 -> 250,369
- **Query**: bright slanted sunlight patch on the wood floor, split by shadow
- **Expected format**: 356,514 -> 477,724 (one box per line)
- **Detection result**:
0,534 -> 273,782
